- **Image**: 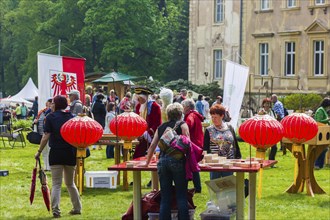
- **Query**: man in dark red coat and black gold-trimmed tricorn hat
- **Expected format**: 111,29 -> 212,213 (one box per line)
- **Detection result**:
133,87 -> 162,158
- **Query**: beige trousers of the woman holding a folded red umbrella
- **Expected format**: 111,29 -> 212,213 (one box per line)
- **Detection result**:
50,165 -> 81,214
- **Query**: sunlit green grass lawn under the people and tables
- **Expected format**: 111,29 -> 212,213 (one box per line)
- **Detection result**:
0,137 -> 330,220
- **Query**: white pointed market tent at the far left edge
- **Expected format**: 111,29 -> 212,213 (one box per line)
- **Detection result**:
0,78 -> 38,107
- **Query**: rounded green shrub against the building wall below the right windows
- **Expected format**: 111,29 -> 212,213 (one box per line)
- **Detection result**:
280,94 -> 323,111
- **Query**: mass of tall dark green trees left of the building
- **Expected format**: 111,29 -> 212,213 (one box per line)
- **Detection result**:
0,0 -> 189,94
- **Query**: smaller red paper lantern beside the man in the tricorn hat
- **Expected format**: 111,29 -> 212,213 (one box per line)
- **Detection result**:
109,112 -> 148,141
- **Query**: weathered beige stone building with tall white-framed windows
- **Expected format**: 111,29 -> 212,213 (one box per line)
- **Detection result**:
188,0 -> 330,110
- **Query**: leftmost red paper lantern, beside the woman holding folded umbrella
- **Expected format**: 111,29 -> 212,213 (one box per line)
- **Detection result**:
61,116 -> 103,148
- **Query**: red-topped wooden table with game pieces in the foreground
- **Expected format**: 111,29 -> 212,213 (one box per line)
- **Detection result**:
108,157 -> 277,220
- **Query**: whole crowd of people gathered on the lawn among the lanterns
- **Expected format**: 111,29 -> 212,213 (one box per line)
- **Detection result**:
0,84 -> 330,219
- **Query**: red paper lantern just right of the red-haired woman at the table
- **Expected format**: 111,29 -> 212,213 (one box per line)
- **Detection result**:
239,115 -> 284,149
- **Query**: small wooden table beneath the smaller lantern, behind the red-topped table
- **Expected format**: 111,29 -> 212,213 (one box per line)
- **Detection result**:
95,134 -> 139,190
